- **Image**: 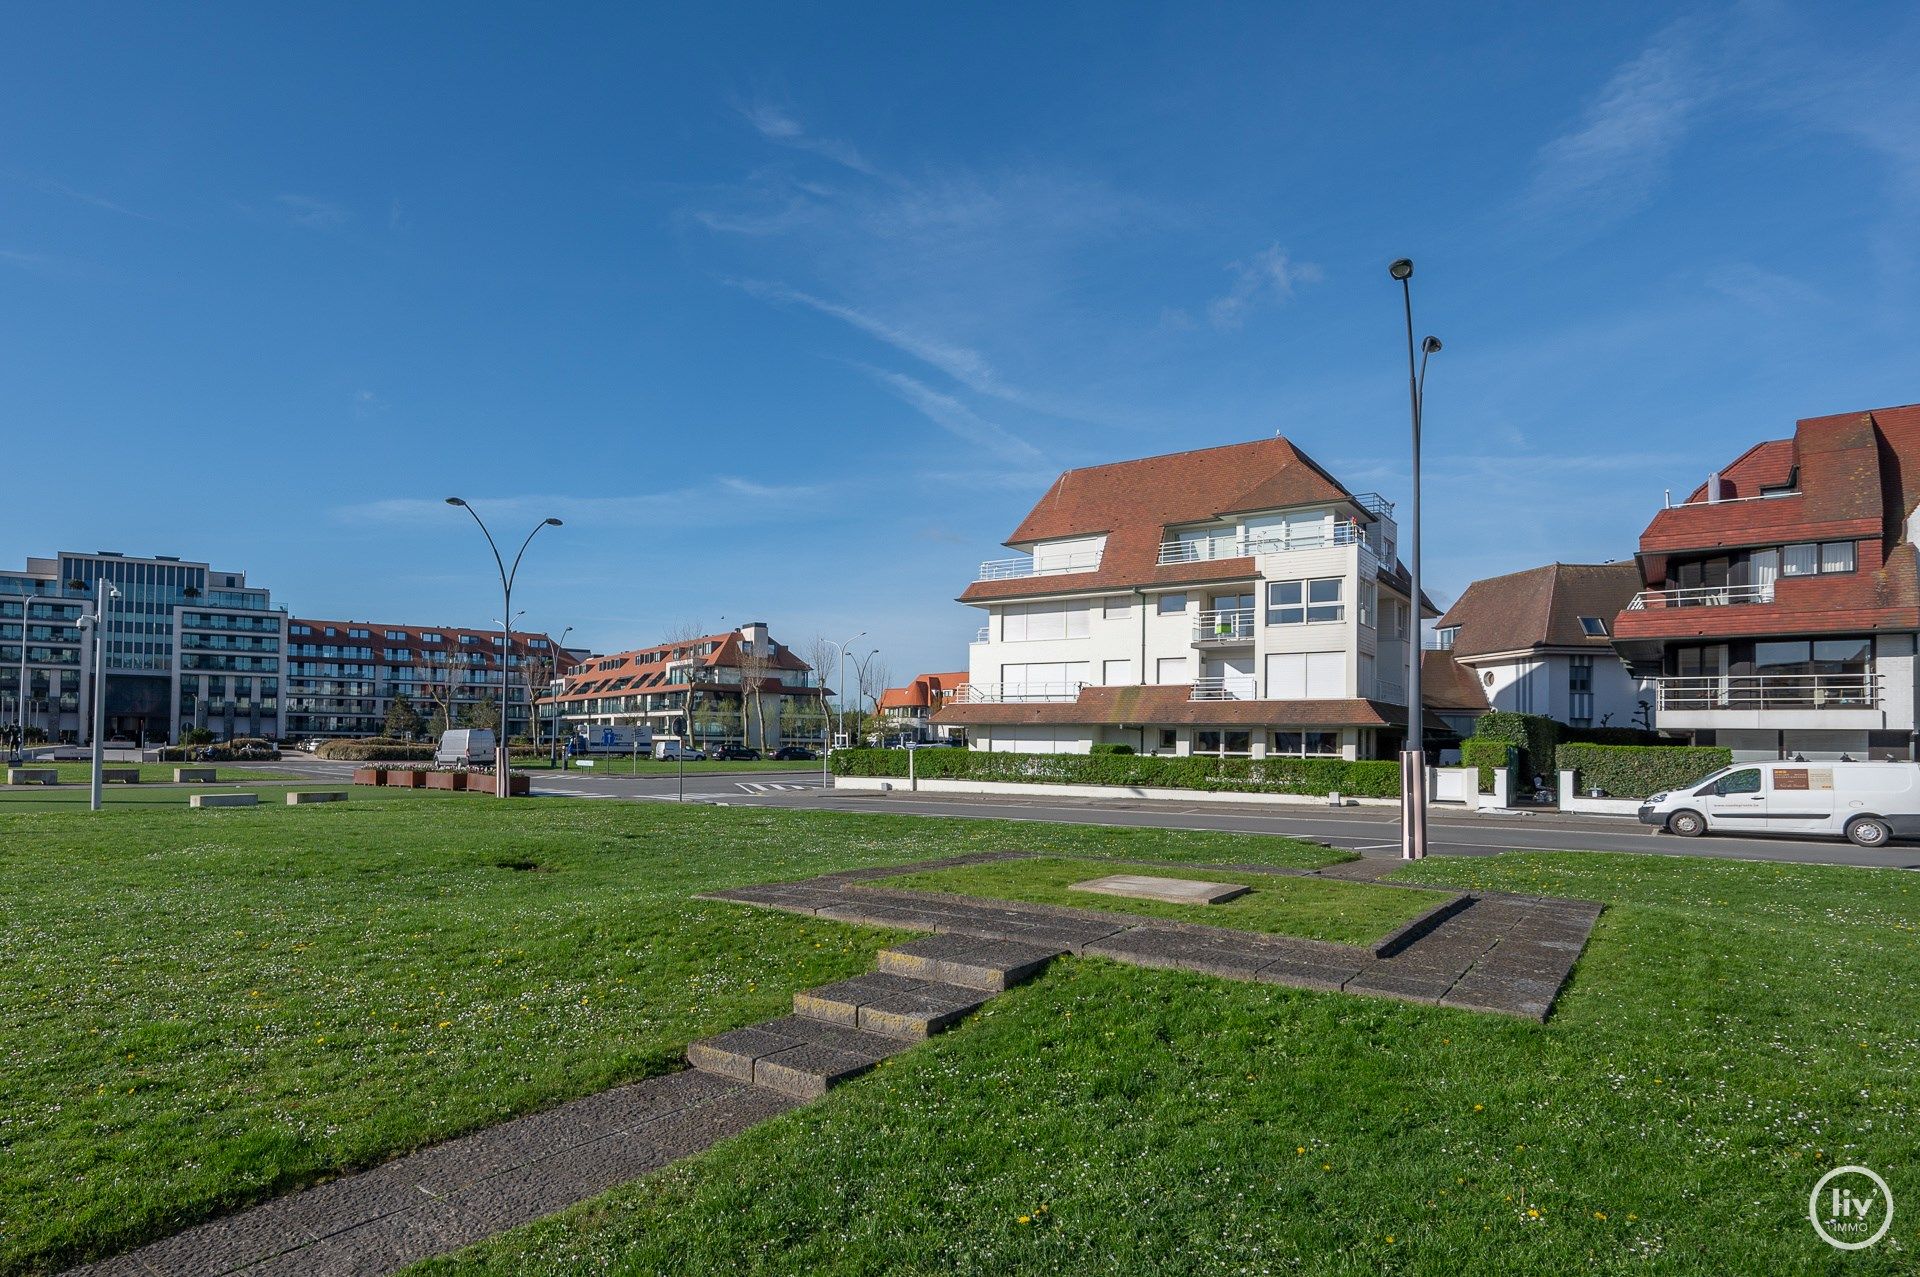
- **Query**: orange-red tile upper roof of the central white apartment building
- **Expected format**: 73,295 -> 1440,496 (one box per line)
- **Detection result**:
960,436 -> 1428,603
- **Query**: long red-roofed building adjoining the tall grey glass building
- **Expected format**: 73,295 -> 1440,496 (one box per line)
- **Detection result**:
286,616 -> 576,739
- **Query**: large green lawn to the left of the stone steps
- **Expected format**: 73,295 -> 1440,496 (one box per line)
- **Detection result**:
0,787 -> 1346,1273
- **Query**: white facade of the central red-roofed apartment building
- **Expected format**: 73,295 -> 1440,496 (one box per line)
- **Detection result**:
968,499 -> 1413,759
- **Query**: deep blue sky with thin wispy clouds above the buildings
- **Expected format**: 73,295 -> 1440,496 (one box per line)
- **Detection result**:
0,4 -> 1920,678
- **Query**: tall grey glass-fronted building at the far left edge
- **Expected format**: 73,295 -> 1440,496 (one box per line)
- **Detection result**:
0,551 -> 286,745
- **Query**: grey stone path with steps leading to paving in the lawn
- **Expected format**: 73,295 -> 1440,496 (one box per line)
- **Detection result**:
69,853 -> 1599,1277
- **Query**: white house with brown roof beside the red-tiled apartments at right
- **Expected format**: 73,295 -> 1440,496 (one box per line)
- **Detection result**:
1423,563 -> 1655,728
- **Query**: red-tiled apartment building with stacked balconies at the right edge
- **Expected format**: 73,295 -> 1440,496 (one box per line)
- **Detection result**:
1613,405 -> 1920,760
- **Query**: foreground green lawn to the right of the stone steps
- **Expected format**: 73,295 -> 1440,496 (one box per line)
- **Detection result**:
420,844 -> 1920,1277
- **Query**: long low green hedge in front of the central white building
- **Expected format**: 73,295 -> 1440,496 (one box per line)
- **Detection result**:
833,749 -> 1400,799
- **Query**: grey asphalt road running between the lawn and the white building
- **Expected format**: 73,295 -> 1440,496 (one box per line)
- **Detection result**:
259,759 -> 1920,868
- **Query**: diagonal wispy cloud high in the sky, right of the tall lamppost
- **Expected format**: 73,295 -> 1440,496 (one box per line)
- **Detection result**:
1523,19 -> 1718,227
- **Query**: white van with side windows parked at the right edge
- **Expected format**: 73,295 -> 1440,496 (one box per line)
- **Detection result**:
1640,762 -> 1920,847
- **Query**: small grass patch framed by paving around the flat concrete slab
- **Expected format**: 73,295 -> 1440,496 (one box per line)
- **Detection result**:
872,856 -> 1444,945
